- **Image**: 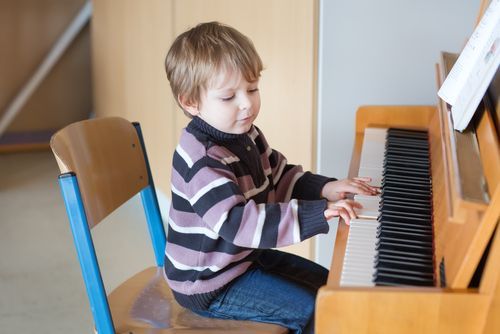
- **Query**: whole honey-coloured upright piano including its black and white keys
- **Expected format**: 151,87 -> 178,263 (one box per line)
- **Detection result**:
316,3 -> 500,334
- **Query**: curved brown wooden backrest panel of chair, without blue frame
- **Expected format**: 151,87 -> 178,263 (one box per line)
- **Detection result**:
50,118 -> 148,227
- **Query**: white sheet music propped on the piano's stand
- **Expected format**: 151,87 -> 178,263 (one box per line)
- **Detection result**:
438,0 -> 500,131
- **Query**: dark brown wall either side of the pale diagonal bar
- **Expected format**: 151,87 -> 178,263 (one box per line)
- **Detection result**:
0,0 -> 92,132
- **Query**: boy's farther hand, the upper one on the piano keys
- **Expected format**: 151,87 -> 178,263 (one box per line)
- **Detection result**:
321,177 -> 380,202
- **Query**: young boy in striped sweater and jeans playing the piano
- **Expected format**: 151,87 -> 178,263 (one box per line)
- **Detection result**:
165,22 -> 377,333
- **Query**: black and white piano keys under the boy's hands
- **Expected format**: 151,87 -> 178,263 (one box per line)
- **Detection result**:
340,128 -> 434,286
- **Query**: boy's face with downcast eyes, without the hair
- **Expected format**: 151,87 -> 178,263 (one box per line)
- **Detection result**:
187,72 -> 260,134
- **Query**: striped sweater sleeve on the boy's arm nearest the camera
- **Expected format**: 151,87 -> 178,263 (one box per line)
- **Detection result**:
176,157 -> 328,248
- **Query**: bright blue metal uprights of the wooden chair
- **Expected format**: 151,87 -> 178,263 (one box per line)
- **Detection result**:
59,123 -> 166,334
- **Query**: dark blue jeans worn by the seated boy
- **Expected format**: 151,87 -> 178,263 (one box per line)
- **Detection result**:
195,250 -> 328,334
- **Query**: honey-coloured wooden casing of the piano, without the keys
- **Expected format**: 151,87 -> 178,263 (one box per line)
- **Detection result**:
316,106 -> 500,333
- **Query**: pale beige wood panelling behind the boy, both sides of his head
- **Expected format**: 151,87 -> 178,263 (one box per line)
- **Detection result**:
92,0 -> 317,258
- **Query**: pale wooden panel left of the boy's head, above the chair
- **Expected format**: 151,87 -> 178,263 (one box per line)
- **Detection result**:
92,0 -> 178,201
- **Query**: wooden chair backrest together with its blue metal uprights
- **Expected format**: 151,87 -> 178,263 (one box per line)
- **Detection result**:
50,117 -> 166,333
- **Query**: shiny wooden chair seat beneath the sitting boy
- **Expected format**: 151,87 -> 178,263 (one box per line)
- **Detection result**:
109,267 -> 288,334
